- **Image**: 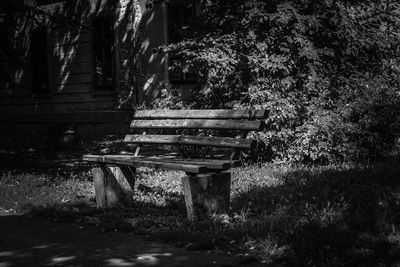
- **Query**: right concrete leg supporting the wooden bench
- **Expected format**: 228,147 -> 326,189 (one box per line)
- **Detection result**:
182,172 -> 231,220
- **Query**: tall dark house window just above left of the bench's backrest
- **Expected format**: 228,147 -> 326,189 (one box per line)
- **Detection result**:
93,18 -> 114,91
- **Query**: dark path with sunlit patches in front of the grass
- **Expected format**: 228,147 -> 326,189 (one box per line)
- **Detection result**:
0,214 -> 263,267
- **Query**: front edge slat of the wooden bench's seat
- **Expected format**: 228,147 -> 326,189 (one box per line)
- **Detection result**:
83,155 -> 208,173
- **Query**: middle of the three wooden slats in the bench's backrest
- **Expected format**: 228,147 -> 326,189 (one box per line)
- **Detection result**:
131,119 -> 263,131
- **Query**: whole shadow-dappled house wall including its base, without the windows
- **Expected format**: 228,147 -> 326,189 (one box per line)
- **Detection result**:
0,0 -> 172,151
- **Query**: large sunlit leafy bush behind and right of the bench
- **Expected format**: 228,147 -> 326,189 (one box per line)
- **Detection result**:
154,0 -> 400,163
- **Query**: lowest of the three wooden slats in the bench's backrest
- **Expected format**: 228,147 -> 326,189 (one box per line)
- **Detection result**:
124,134 -> 256,149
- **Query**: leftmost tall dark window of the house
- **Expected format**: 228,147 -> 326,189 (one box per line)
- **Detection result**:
30,26 -> 49,94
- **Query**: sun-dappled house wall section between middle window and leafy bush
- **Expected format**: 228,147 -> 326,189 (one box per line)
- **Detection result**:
119,0 -> 169,108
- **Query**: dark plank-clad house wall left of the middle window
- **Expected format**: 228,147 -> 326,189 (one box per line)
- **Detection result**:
0,0 -> 118,113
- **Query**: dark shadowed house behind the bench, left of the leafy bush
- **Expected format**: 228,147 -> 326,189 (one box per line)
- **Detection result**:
0,0 -> 200,149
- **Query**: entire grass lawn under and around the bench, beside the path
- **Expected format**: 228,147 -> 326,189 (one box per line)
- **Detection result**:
0,153 -> 400,266
